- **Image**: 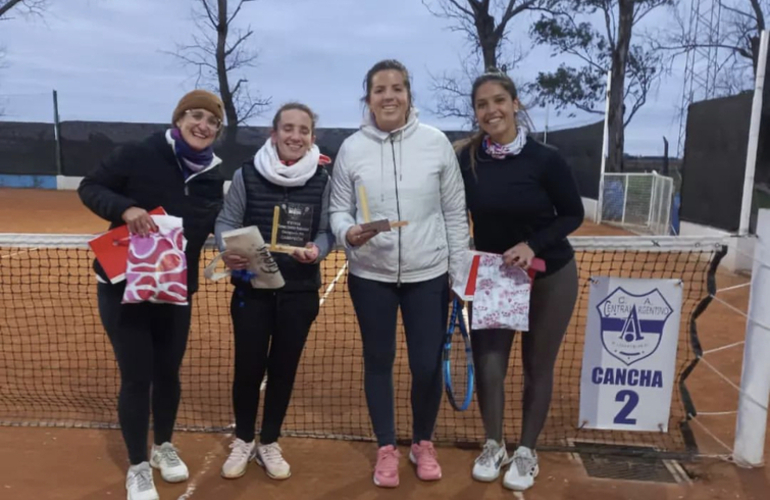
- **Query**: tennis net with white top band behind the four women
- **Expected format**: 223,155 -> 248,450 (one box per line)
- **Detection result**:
0,234 -> 726,453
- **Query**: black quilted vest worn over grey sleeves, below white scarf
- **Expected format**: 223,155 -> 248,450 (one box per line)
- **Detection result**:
241,162 -> 329,292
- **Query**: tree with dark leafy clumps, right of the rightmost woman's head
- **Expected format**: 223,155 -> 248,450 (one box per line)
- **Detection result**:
532,0 -> 673,172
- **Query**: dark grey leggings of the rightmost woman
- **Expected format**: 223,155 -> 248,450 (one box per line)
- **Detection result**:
471,260 -> 578,449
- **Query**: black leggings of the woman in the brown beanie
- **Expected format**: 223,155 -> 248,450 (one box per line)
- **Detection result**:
97,283 -> 192,465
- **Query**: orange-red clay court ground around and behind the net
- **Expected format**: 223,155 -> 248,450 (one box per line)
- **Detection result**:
0,189 -> 770,500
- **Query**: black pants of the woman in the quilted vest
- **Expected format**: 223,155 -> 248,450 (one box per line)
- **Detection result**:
230,288 -> 319,444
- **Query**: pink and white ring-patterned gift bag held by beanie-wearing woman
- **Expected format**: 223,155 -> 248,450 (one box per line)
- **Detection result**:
122,215 -> 188,306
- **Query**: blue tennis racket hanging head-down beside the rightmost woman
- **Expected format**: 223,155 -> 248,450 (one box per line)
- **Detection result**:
442,298 -> 474,411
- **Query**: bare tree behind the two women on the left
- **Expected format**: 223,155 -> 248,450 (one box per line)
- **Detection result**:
173,0 -> 270,132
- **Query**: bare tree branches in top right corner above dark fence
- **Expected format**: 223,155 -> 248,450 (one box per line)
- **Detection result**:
651,0 -> 770,96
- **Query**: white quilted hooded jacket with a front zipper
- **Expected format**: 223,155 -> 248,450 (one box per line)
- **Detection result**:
329,109 -> 470,283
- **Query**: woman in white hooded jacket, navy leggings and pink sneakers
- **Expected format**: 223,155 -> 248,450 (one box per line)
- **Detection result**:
329,60 -> 470,487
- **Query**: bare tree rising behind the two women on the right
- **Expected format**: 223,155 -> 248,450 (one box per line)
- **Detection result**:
422,0 -> 558,125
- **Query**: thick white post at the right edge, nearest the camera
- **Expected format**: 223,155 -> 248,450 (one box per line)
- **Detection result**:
733,209 -> 770,467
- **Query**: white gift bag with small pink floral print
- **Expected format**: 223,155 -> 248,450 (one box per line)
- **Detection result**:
471,253 -> 532,332
